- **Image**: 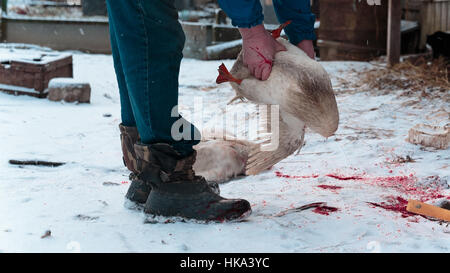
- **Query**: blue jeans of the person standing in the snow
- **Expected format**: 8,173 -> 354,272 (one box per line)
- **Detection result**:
106,0 -> 199,155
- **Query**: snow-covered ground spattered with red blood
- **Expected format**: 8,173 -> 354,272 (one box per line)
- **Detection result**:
0,44 -> 450,252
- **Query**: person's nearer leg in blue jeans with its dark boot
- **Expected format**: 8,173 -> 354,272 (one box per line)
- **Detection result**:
108,0 -> 251,220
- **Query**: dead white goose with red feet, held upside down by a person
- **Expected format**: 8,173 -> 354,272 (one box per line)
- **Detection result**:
194,24 -> 339,182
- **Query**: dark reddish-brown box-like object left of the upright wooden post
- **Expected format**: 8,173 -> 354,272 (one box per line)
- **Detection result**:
317,0 -> 388,61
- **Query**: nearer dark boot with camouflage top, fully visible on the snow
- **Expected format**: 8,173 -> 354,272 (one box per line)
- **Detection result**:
134,143 -> 251,221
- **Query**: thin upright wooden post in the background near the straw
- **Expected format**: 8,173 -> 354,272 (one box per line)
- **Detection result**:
387,0 -> 402,66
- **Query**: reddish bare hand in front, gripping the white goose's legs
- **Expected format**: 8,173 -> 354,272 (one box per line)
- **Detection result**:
239,24 -> 287,81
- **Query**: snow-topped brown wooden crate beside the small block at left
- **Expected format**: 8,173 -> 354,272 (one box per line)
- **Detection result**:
0,53 -> 73,98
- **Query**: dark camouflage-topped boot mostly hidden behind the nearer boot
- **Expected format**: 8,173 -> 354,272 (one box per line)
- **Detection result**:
119,124 -> 151,204
